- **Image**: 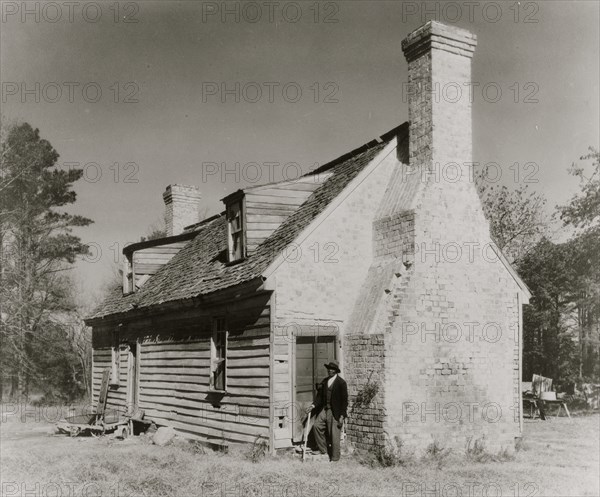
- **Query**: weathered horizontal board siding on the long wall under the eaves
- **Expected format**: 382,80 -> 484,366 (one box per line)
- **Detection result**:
94,293 -> 271,444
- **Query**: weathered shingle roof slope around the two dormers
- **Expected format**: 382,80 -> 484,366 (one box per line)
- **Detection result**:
88,125 -> 408,320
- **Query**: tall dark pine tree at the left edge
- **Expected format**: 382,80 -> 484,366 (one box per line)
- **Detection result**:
0,123 -> 92,398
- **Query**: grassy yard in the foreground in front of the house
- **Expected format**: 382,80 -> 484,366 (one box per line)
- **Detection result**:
0,406 -> 600,497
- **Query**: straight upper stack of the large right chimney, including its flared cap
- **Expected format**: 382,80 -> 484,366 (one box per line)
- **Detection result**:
402,21 -> 477,180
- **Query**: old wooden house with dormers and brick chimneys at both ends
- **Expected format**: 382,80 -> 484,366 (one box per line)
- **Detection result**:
87,22 -> 530,449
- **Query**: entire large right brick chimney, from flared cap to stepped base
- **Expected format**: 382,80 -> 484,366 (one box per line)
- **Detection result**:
344,22 -> 528,453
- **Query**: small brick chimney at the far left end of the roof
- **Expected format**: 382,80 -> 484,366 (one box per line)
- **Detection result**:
163,185 -> 202,236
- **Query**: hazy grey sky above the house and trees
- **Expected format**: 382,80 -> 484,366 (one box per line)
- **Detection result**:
0,0 -> 600,298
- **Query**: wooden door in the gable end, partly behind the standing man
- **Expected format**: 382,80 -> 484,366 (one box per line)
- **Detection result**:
292,336 -> 337,442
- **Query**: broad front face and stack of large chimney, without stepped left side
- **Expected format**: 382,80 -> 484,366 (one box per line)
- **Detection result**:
385,22 -> 520,451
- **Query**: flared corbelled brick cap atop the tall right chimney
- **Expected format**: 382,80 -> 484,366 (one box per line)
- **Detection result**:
402,21 -> 477,61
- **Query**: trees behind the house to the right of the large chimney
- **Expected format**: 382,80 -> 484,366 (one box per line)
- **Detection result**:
478,148 -> 600,388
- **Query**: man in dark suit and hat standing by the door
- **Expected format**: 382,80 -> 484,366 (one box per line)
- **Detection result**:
309,361 -> 348,461
